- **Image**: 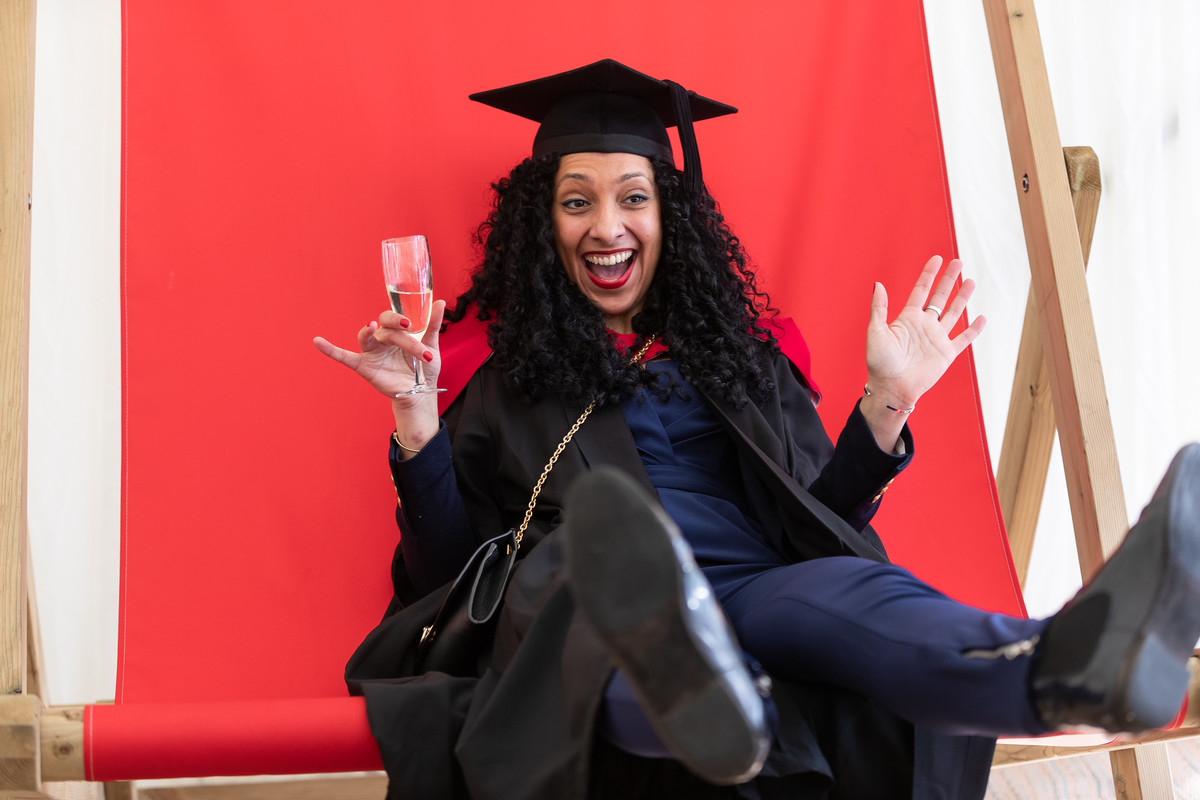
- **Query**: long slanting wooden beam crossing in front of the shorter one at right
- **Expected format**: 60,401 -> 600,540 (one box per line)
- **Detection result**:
984,0 -> 1128,578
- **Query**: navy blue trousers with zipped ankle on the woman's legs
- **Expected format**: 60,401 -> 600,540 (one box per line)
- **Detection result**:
600,557 -> 1045,758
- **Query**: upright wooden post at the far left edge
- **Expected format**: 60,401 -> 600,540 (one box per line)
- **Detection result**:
0,0 -> 34,693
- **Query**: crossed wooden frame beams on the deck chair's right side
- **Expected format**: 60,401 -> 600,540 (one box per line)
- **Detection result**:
984,0 -> 1200,800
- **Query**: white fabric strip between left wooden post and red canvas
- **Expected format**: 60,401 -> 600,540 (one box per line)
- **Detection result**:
29,0 -> 121,704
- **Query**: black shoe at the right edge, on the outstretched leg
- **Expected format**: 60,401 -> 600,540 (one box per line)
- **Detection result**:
1031,444 -> 1200,733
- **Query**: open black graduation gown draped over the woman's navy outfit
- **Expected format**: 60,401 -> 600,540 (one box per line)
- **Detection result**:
346,355 -> 995,800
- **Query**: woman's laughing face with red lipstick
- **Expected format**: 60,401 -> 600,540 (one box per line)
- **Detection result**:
551,152 -> 662,333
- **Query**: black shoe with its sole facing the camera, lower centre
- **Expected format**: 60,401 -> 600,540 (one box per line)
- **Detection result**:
563,469 -> 770,784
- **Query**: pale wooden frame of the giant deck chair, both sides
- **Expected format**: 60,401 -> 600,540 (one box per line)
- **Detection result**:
0,0 -> 1200,800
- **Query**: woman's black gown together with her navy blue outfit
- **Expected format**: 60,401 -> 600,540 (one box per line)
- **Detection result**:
346,345 -> 1042,800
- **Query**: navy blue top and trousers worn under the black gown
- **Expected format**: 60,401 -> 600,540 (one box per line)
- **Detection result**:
605,360 -> 1045,754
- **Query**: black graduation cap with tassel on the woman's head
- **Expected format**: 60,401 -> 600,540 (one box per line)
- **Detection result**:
470,59 -> 738,190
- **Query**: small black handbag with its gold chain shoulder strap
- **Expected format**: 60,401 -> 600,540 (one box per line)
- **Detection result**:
416,336 -> 658,675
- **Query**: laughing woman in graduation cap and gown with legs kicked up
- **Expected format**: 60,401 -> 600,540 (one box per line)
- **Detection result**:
317,61 -> 1200,799
